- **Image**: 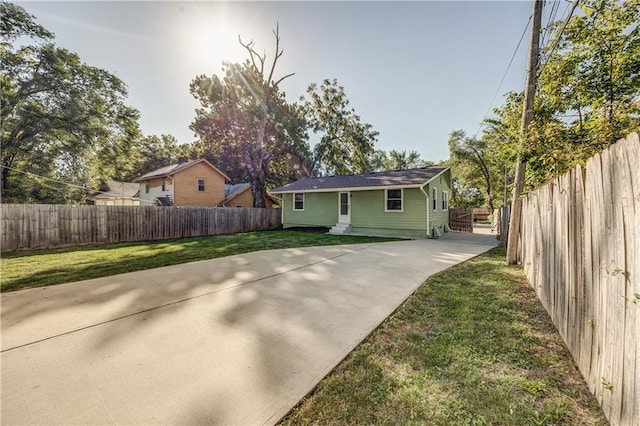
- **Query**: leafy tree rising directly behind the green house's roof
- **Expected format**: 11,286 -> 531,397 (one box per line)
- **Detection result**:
304,79 -> 378,174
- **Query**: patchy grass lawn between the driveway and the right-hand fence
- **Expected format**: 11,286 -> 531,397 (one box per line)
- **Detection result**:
282,248 -> 607,425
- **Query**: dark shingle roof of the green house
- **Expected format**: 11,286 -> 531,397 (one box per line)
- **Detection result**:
271,166 -> 449,194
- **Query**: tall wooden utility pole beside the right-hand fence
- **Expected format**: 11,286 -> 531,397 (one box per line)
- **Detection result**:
507,0 -> 543,265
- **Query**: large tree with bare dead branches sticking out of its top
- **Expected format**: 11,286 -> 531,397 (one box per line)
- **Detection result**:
190,25 -> 309,207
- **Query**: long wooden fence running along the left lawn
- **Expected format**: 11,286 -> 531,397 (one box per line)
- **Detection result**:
0,204 -> 281,251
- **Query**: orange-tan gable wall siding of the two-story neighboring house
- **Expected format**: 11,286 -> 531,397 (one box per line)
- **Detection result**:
172,162 -> 225,207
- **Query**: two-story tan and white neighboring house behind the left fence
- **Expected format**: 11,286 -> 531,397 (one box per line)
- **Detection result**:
134,158 -> 230,207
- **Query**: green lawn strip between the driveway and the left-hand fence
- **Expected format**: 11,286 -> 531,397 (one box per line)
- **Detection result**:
0,231 -> 392,292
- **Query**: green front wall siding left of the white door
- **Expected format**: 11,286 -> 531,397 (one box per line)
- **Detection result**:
282,192 -> 338,228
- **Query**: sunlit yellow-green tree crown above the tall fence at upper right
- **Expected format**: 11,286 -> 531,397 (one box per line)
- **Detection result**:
540,0 -> 640,150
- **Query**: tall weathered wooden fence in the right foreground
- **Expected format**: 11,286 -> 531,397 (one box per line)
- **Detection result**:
521,133 -> 640,425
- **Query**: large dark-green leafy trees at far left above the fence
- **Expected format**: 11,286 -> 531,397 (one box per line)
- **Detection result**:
0,2 -> 139,202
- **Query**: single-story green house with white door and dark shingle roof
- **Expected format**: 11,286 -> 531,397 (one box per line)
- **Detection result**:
271,167 -> 451,238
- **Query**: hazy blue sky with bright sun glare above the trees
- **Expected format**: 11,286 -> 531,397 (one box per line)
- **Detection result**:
16,0 -> 532,161
